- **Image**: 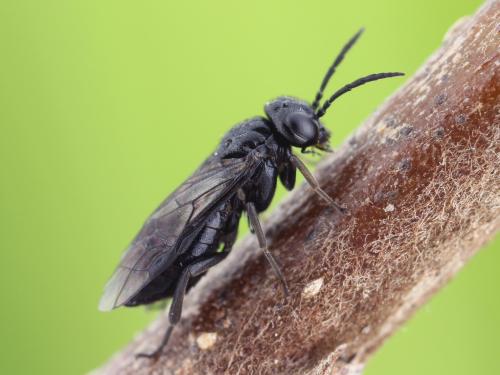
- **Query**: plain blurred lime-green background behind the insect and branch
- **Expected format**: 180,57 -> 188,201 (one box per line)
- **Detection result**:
0,0 -> 500,375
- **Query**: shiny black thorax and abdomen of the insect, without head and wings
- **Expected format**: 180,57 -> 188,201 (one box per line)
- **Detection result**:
125,117 -> 296,306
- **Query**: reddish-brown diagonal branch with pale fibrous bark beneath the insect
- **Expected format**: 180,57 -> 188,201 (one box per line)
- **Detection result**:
95,1 -> 500,374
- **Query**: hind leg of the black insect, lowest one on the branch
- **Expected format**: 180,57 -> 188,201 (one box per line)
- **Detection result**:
137,253 -> 227,358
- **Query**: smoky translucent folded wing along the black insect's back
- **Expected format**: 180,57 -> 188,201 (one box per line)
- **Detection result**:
99,158 -> 257,311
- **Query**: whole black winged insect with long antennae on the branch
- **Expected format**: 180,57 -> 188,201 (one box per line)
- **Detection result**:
99,29 -> 402,357
